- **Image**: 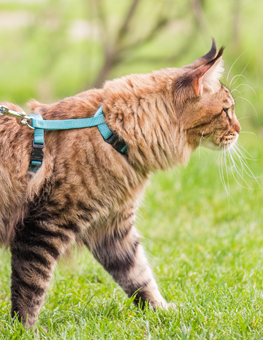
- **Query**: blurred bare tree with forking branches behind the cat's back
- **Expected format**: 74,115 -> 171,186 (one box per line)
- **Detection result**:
90,0 -> 206,87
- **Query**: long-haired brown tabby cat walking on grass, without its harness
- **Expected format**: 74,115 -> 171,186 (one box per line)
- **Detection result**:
0,40 -> 241,327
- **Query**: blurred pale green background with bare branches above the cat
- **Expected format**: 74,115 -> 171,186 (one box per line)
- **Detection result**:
0,0 -> 263,126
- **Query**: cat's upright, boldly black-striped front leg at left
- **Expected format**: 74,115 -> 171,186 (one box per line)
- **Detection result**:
11,209 -> 74,328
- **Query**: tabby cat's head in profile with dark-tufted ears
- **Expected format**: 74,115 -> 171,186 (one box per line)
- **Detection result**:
173,40 -> 241,150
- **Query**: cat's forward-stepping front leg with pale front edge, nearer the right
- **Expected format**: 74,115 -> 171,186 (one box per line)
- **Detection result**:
85,212 -> 169,309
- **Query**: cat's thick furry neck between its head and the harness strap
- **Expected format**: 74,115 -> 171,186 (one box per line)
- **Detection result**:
103,70 -> 192,171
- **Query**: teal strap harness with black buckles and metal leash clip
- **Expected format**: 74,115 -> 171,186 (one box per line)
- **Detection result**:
0,105 -> 127,173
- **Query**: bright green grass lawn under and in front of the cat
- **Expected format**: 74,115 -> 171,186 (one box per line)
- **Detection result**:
0,121 -> 263,340
